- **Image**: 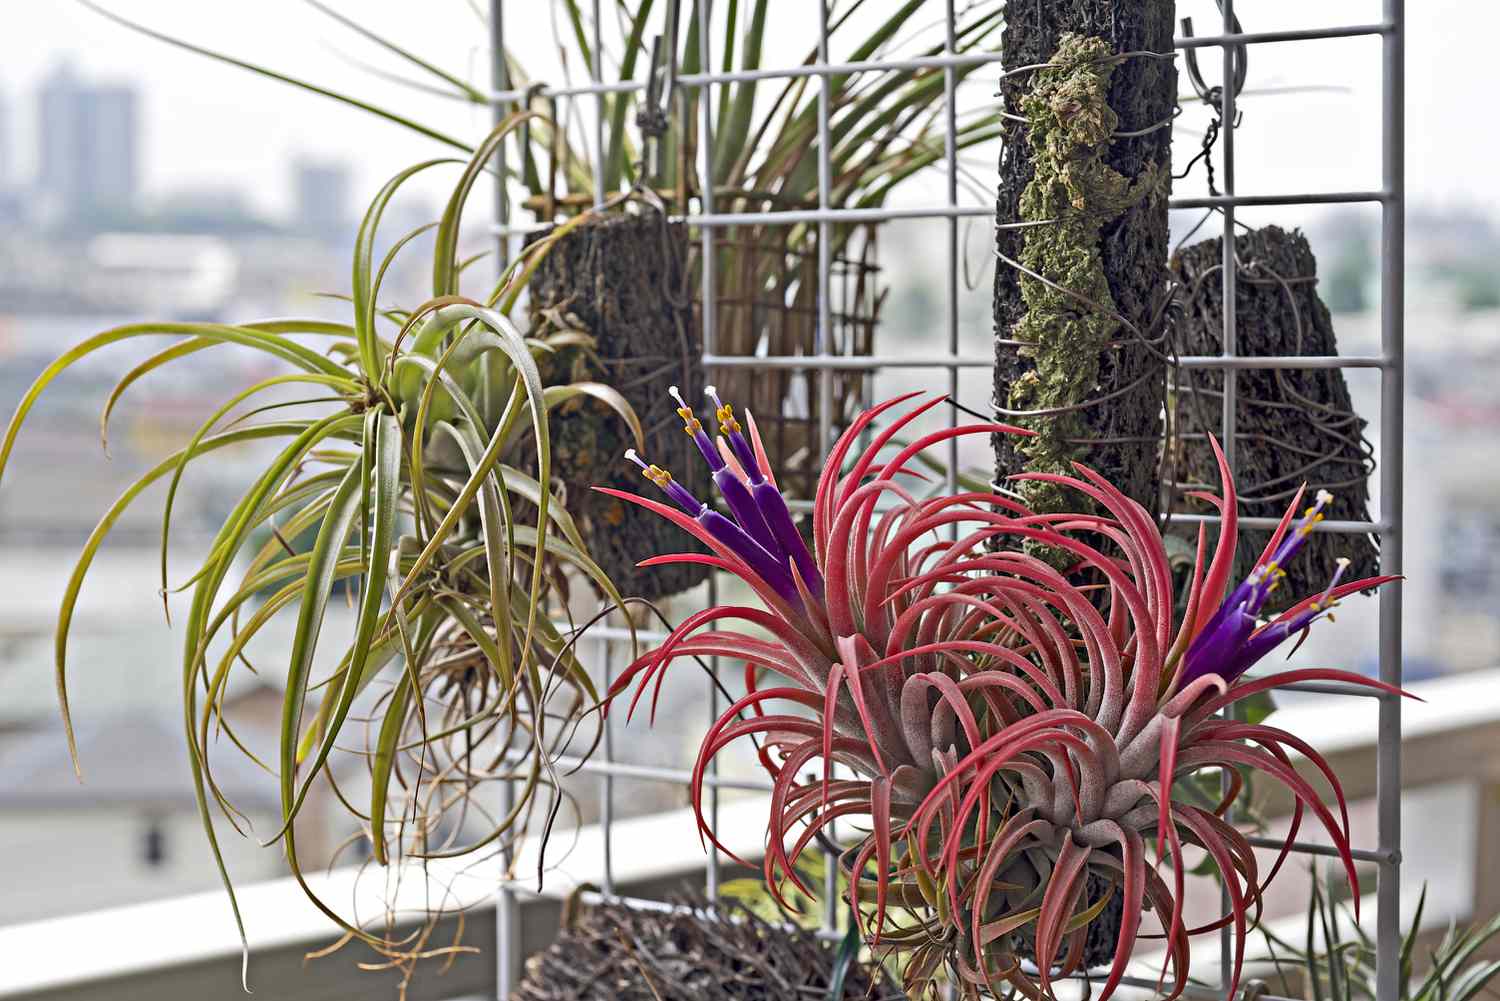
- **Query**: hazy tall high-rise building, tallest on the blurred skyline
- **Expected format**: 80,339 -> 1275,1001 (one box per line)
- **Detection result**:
38,63 -> 141,222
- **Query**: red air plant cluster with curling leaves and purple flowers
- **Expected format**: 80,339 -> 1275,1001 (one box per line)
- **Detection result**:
606,390 -> 1395,1001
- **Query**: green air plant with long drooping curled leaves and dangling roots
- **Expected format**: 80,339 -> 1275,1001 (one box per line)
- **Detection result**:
0,116 -> 641,984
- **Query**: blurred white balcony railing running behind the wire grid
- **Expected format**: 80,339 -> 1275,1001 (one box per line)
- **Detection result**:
0,669 -> 1500,1001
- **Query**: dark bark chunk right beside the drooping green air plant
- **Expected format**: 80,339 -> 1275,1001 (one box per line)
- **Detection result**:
530,213 -> 708,599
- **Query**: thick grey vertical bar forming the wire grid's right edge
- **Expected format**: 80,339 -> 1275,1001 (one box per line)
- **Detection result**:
1376,0 -> 1406,1001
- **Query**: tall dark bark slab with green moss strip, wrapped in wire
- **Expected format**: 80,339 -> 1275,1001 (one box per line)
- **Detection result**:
995,0 -> 1176,528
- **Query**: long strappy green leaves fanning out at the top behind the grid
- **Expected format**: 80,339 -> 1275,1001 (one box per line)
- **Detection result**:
83,0 -> 1004,235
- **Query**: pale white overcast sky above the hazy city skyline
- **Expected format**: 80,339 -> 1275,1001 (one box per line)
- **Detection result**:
0,0 -> 1500,221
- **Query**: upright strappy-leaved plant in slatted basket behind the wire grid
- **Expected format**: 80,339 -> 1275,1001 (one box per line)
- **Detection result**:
76,0 -> 1008,525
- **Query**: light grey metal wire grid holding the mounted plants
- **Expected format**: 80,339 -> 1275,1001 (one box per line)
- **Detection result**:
489,0 -> 1406,1001
